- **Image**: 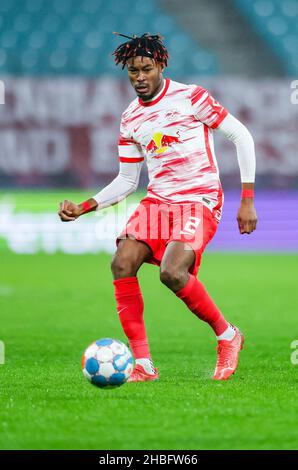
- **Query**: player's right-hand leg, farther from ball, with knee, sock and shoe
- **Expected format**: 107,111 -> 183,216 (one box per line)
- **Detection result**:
160,241 -> 244,380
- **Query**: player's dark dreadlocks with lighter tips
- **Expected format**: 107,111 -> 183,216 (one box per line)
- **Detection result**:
113,33 -> 169,69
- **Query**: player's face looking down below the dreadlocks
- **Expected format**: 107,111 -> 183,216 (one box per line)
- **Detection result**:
127,56 -> 164,101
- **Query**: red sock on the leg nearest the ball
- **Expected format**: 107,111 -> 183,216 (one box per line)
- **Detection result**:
113,277 -> 150,359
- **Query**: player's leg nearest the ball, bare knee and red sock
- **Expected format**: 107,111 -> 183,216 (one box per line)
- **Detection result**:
111,238 -> 157,379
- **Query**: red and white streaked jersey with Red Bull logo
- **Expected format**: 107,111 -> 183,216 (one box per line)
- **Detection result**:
119,78 -> 228,220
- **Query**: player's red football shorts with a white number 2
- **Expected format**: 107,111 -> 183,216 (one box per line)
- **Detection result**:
116,197 -> 218,276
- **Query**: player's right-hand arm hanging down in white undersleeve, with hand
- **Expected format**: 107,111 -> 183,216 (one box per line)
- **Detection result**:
217,114 -> 257,234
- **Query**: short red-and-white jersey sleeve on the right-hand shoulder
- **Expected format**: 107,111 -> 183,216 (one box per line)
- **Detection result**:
190,86 -> 228,129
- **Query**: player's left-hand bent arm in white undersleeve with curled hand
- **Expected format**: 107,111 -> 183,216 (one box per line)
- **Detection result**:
58,161 -> 142,222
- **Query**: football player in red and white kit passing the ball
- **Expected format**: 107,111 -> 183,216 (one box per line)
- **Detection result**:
59,34 -> 257,382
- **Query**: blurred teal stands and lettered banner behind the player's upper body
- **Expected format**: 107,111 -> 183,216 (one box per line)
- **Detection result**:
0,0 -> 298,189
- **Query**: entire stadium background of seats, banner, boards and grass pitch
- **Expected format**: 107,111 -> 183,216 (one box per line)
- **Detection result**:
0,0 -> 298,449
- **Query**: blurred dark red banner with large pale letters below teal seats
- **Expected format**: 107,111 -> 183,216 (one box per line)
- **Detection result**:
0,77 -> 298,188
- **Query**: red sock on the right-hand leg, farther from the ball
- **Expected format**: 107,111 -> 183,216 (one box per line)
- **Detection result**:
176,274 -> 229,336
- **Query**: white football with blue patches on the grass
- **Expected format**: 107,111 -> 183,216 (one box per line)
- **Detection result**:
82,338 -> 133,388
